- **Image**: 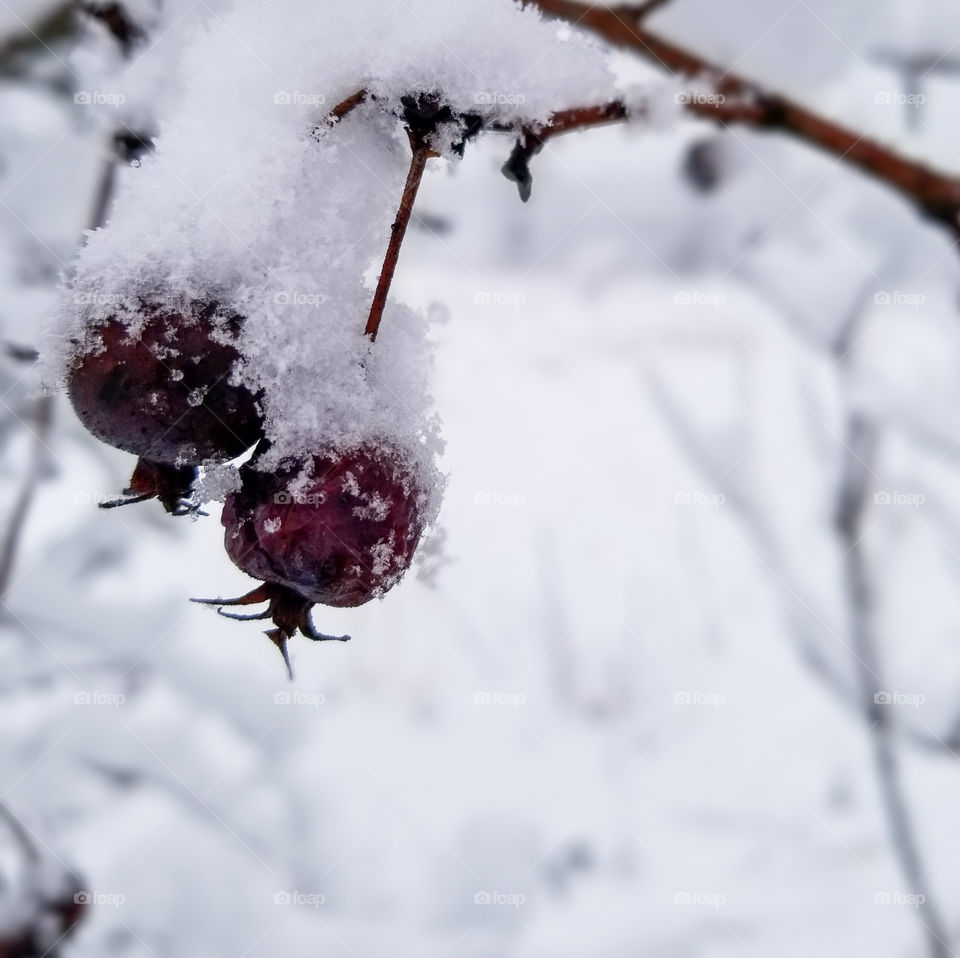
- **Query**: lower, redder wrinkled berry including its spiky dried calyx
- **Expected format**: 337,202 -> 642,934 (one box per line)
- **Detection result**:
195,446 -> 427,680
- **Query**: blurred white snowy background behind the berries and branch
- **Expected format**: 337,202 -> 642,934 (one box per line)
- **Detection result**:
0,0 -> 960,958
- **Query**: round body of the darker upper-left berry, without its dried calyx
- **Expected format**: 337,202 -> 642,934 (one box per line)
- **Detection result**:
67,303 -> 261,465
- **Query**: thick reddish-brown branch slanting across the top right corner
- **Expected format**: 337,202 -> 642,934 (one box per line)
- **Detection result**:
526,0 -> 960,233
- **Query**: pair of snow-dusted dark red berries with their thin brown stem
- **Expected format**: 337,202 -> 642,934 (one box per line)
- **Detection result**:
65,93 -> 482,670
